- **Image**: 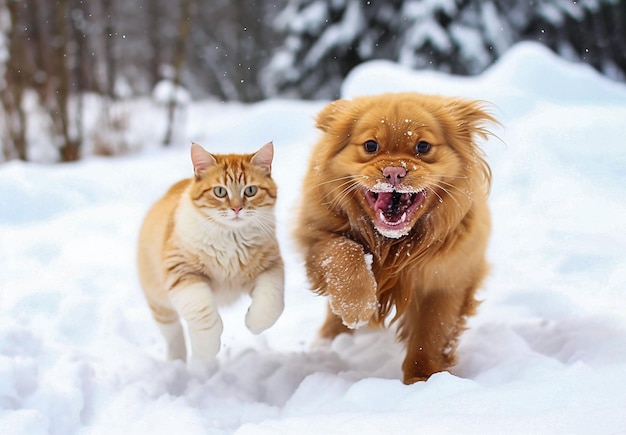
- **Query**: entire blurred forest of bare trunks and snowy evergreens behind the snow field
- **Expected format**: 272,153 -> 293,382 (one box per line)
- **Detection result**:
0,0 -> 626,161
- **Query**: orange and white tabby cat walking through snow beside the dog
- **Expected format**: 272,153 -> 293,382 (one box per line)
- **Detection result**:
137,142 -> 284,361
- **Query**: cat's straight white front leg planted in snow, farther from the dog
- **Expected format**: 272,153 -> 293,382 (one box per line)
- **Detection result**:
170,281 -> 223,361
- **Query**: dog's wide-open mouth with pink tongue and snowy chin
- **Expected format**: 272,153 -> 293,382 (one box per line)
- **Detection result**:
366,190 -> 426,238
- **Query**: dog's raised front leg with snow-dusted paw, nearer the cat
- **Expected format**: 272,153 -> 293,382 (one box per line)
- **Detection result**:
306,236 -> 378,329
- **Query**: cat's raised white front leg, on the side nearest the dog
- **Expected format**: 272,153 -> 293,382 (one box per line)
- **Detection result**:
246,265 -> 285,334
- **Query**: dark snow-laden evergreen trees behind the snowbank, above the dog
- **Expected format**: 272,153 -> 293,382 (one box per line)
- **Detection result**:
265,0 -> 626,98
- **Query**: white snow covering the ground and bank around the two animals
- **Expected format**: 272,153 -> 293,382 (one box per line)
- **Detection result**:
0,44 -> 626,434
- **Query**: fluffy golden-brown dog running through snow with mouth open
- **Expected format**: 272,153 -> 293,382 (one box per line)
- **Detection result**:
295,93 -> 496,384
